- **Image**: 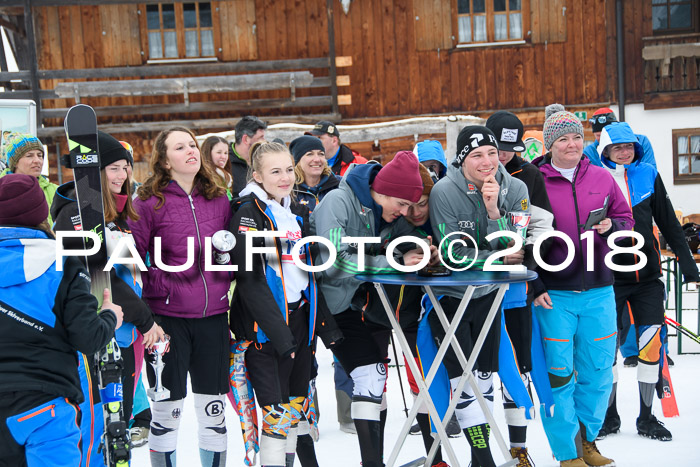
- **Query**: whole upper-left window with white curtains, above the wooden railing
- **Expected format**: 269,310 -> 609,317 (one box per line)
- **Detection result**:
146,2 -> 215,60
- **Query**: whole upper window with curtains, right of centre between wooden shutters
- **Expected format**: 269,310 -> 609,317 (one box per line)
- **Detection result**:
457,0 -> 523,44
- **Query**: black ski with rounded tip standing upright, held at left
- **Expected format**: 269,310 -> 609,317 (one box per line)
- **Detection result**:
63,104 -> 131,467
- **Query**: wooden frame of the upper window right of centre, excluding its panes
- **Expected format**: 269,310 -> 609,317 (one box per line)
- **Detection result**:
452,0 -> 530,48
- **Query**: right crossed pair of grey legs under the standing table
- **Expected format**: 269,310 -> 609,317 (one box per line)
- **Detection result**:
425,284 -> 517,466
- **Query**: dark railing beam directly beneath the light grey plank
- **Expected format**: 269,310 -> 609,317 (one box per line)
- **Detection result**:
41,96 -> 331,119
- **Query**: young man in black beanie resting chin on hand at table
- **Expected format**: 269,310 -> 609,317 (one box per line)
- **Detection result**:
428,126 -> 530,467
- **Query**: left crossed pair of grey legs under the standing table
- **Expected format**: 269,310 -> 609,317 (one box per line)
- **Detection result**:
374,283 -> 460,467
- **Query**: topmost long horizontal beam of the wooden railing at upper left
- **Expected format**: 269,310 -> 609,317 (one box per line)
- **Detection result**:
0,57 -> 330,81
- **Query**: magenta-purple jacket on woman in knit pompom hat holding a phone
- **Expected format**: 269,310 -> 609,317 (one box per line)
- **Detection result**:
532,154 -> 634,290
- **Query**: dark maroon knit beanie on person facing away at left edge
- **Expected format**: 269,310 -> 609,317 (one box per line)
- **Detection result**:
0,174 -> 49,227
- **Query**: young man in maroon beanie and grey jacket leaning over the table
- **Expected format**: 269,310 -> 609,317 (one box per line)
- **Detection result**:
311,151 -> 437,467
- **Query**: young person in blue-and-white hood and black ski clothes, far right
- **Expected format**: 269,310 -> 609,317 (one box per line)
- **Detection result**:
598,122 -> 700,441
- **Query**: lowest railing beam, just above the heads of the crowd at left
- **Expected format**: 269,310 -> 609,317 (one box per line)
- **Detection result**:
37,114 -> 341,138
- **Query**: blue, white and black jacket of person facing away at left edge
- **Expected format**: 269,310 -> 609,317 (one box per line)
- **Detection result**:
0,227 -> 117,403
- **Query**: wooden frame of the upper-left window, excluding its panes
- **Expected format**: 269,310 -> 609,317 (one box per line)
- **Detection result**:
139,0 -> 221,63
